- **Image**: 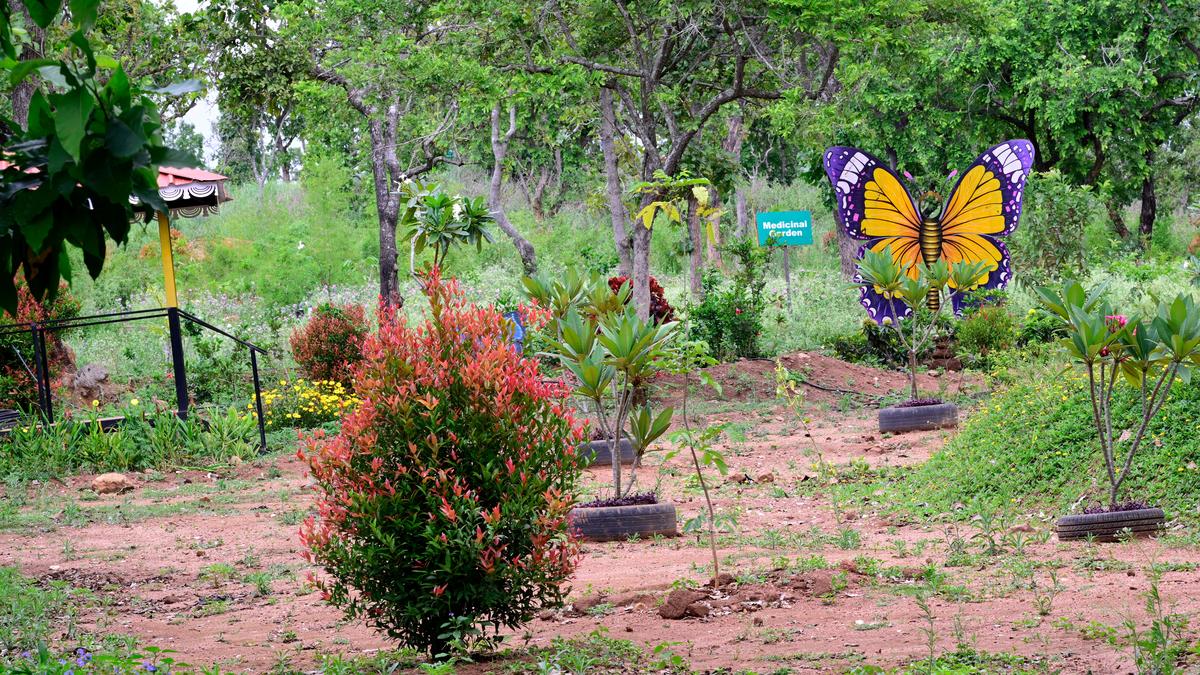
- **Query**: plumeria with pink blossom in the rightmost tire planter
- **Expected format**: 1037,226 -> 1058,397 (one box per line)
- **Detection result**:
1038,281 -> 1200,510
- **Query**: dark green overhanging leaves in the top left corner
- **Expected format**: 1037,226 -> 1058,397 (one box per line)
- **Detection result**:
0,0 -> 194,312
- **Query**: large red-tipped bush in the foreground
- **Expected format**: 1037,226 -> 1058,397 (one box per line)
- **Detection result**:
300,273 -> 583,655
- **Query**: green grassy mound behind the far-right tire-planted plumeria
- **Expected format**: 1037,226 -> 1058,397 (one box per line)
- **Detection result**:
840,369 -> 1200,518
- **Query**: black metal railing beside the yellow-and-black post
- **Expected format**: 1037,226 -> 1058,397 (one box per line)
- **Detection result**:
0,307 -> 268,450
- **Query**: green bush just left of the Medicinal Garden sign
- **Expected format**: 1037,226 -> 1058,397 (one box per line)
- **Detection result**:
689,238 -> 772,360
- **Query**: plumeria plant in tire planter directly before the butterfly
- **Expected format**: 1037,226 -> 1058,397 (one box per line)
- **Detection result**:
857,246 -> 988,401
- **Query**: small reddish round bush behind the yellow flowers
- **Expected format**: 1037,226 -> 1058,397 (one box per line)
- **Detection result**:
290,303 -> 371,384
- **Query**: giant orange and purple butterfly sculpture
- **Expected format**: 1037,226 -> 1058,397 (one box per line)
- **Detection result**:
824,139 -> 1033,322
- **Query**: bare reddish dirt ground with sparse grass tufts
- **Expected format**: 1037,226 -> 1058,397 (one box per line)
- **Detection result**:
0,354 -> 1200,673
